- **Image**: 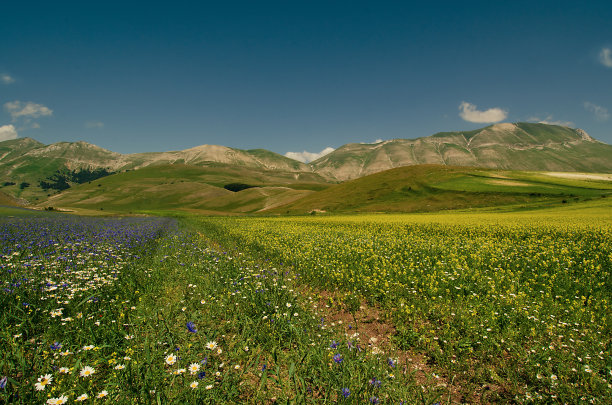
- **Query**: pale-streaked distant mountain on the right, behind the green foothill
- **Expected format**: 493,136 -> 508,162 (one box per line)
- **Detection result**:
311,123 -> 612,181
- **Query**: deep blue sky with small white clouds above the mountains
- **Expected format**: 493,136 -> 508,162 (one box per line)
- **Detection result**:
0,1 -> 612,161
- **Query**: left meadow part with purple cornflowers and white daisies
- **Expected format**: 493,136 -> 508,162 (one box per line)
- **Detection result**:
0,215 -> 445,404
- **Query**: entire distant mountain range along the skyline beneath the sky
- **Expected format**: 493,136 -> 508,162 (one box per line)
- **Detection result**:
0,123 -> 612,205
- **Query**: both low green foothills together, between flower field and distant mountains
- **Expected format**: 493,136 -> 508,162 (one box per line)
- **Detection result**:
40,165 -> 612,214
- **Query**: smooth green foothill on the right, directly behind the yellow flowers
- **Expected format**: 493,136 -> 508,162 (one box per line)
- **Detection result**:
271,165 -> 612,214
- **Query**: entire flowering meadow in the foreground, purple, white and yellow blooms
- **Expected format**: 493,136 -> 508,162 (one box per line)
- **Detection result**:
0,204 -> 612,404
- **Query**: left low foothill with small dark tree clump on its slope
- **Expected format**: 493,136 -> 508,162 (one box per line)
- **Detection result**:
40,164 -> 327,213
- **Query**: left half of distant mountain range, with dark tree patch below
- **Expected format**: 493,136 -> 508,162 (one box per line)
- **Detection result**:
0,138 -> 316,203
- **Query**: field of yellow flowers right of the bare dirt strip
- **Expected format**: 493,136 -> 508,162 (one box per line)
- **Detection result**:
198,207 -> 612,403
